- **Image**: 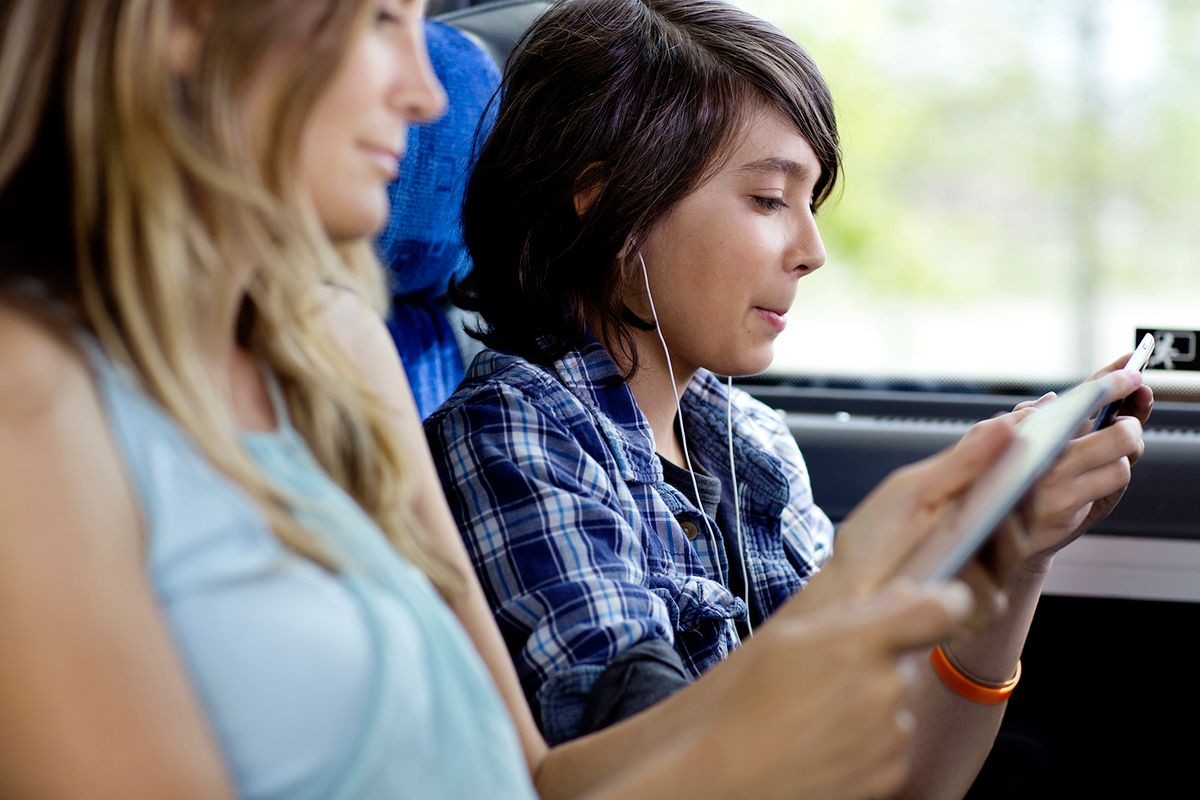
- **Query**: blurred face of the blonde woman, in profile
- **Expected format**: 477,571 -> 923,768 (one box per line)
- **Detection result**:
299,0 -> 446,241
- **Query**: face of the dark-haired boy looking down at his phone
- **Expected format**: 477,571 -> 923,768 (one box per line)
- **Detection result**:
626,108 -> 826,375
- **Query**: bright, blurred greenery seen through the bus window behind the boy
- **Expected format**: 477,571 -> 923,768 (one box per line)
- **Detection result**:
740,0 -> 1200,399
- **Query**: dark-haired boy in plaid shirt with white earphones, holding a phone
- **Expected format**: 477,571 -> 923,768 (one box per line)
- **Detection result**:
426,0 -> 1151,796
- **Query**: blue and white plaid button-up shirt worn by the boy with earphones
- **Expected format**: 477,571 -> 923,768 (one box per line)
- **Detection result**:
426,342 -> 833,744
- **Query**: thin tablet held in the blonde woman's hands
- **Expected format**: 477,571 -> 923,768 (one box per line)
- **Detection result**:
900,377 -> 1111,583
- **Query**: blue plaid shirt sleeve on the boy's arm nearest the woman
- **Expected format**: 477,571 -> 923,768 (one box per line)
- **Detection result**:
427,385 -> 674,744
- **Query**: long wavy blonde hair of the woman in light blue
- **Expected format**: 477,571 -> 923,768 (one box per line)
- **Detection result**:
0,0 -> 462,595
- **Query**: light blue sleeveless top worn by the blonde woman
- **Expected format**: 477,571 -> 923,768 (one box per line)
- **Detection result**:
85,342 -> 534,800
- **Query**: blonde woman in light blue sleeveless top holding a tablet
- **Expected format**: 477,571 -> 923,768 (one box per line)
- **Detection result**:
0,0 -> 1032,798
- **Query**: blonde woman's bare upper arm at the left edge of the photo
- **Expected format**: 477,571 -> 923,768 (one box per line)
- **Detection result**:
0,306 -> 233,800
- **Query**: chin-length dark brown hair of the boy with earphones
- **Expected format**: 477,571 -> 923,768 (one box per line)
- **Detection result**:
452,0 -> 841,374
